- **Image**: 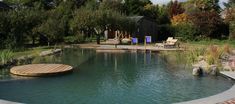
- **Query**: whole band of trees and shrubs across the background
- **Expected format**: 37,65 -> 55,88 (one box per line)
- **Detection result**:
0,0 -> 235,49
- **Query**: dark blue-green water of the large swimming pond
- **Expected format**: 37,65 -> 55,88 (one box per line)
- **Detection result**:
0,49 -> 233,104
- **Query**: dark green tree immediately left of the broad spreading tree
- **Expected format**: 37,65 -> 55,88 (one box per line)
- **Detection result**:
35,2 -> 74,43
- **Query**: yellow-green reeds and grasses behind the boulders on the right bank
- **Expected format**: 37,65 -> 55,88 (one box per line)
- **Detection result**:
160,44 -> 231,72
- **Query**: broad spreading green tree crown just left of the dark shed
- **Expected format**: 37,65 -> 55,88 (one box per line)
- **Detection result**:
70,4 -> 135,38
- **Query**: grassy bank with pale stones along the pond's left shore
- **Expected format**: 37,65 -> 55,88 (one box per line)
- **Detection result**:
0,46 -> 61,68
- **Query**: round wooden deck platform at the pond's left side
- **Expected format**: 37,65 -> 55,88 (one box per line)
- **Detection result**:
10,64 -> 73,77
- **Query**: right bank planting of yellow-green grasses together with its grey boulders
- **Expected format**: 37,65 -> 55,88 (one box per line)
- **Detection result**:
161,42 -> 235,75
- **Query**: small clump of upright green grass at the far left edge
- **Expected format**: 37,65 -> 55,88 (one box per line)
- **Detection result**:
0,50 -> 13,64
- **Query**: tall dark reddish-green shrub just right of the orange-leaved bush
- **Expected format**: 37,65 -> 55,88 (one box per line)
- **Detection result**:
184,0 -> 224,39
